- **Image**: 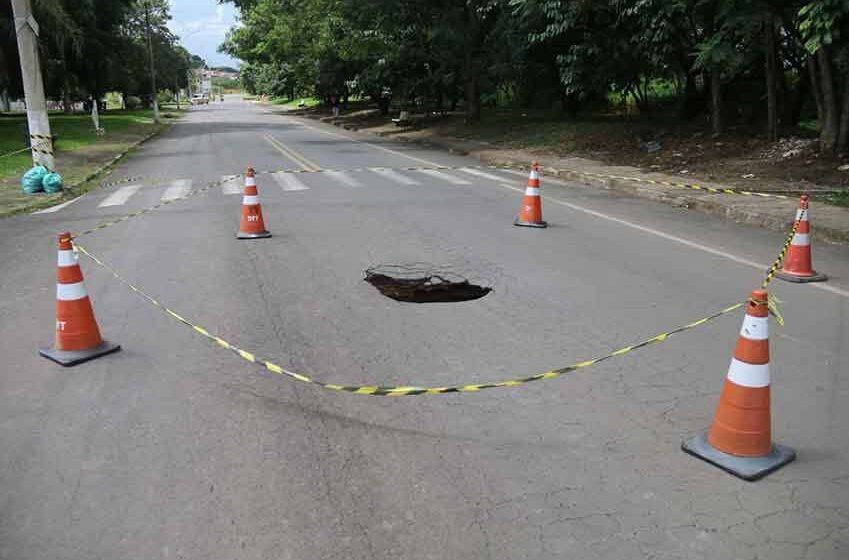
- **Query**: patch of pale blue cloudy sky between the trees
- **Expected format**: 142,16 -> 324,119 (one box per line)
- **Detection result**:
168,0 -> 238,66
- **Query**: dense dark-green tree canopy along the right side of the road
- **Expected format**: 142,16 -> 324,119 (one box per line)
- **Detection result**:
222,0 -> 849,154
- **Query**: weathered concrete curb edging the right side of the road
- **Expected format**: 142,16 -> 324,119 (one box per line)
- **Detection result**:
302,115 -> 849,244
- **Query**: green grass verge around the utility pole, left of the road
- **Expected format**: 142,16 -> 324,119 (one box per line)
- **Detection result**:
0,110 -> 179,216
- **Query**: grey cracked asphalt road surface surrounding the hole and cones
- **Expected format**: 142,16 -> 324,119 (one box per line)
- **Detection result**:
0,98 -> 849,560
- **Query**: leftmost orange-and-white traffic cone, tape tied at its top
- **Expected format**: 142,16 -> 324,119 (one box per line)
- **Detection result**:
38,232 -> 121,366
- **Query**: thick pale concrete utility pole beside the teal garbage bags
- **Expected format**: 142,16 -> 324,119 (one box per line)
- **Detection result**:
12,0 -> 55,171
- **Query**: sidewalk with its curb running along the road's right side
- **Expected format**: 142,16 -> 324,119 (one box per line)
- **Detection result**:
290,106 -> 849,244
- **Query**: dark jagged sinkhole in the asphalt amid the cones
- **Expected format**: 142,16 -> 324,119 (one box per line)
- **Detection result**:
366,263 -> 492,303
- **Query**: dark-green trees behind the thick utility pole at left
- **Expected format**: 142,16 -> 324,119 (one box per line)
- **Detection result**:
0,0 -> 204,110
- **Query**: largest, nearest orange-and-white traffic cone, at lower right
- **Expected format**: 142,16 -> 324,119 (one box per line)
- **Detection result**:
681,290 -> 796,480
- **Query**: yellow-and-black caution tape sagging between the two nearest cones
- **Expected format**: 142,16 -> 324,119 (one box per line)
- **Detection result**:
74,243 -> 745,397
